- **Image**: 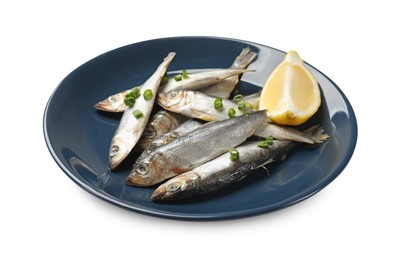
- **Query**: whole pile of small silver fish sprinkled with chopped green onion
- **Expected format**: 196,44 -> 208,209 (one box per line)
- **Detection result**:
94,48 -> 328,202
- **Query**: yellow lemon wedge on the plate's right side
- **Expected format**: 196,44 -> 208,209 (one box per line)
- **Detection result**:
259,51 -> 321,125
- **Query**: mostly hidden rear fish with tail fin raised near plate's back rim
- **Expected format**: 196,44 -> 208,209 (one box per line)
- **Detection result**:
200,47 -> 257,98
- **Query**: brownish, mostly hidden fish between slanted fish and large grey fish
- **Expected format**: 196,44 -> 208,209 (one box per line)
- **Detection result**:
136,110 -> 189,151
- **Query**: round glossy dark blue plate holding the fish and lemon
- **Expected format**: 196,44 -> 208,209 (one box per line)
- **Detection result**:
43,37 -> 357,220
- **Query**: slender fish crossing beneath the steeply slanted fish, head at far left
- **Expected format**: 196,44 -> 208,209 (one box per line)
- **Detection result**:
93,68 -> 250,112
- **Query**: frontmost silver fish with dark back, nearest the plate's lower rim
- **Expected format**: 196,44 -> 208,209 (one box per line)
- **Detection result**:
151,126 -> 323,202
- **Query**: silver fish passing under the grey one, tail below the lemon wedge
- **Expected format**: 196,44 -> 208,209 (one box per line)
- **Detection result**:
157,90 -> 321,144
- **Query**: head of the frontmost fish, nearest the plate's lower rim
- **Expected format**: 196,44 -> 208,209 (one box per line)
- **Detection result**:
151,171 -> 199,202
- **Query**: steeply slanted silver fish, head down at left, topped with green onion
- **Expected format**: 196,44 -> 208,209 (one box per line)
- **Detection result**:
109,52 -> 175,170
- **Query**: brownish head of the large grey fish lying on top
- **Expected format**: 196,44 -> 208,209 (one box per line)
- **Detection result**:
125,153 -> 167,187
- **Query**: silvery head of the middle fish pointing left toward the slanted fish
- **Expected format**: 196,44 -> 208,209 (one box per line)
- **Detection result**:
157,90 -> 194,110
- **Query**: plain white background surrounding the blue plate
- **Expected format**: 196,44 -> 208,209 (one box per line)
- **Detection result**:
0,0 -> 394,259
